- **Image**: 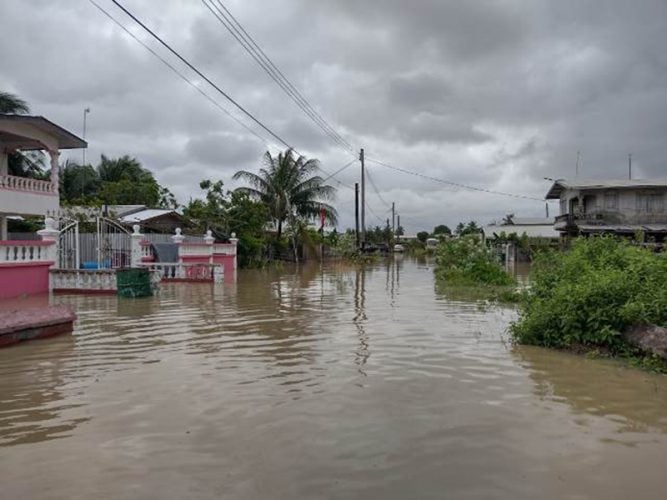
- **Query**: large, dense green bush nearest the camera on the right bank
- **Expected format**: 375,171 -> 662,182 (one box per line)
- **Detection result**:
511,237 -> 667,354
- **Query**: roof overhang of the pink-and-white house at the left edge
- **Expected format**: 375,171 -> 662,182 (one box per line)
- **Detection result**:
0,114 -> 88,150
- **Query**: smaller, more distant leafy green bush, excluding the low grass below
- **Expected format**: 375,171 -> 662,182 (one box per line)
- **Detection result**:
435,235 -> 514,286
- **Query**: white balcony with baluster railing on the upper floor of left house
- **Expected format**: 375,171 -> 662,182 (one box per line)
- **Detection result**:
0,175 -> 59,216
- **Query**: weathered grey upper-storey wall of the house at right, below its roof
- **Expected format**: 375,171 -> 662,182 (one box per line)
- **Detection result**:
560,187 -> 667,225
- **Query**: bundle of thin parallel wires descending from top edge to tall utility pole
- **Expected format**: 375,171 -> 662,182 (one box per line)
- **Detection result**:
201,0 -> 354,151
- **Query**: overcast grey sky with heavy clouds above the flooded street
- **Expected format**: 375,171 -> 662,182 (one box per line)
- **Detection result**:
0,0 -> 667,232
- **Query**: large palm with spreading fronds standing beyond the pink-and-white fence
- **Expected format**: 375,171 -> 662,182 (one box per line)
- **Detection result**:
234,149 -> 338,238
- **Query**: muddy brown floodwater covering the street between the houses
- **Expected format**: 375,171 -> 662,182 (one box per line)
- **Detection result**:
0,258 -> 667,499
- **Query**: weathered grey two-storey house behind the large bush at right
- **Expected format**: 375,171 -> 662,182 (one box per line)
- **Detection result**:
546,179 -> 667,242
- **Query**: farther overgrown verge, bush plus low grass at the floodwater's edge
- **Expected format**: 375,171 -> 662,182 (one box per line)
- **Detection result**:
435,235 -> 517,302
